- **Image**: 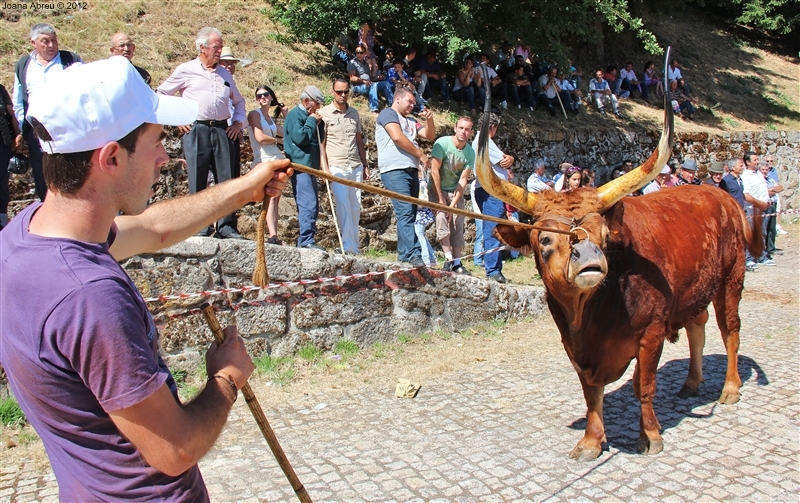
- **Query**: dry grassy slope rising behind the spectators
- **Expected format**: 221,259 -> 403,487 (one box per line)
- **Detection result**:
0,0 -> 800,137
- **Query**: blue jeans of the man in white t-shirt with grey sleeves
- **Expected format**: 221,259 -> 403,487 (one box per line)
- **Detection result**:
381,168 -> 422,262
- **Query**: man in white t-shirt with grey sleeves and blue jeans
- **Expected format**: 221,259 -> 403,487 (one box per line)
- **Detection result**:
375,87 -> 436,266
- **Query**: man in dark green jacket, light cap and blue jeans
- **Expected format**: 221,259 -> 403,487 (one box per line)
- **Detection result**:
283,86 -> 325,250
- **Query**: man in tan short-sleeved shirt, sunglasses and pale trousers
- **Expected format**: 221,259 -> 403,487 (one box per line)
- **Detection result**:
319,79 -> 369,255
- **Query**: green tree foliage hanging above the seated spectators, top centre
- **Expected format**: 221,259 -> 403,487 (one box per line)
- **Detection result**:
272,0 -> 662,62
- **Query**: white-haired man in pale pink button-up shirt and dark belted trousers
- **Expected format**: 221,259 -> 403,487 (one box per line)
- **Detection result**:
156,27 -> 246,239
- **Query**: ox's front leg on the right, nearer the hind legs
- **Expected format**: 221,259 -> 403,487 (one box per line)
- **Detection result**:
633,334 -> 664,454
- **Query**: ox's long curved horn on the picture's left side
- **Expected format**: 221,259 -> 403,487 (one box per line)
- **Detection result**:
475,63 -> 536,213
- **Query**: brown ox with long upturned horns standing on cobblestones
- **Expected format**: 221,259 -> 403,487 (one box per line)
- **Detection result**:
476,55 -> 762,460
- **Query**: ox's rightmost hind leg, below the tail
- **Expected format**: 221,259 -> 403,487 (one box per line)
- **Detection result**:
714,282 -> 742,405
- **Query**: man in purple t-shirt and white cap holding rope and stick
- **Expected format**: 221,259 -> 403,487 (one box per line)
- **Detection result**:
0,56 -> 288,501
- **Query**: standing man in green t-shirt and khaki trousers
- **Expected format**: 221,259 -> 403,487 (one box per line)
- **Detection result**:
428,116 -> 475,274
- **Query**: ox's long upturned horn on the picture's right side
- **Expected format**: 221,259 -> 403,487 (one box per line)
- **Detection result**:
592,47 -> 674,212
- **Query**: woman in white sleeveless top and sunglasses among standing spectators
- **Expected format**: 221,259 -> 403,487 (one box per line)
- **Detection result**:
247,85 -> 287,245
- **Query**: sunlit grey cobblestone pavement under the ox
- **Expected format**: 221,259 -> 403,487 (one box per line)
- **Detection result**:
0,233 -> 800,502
